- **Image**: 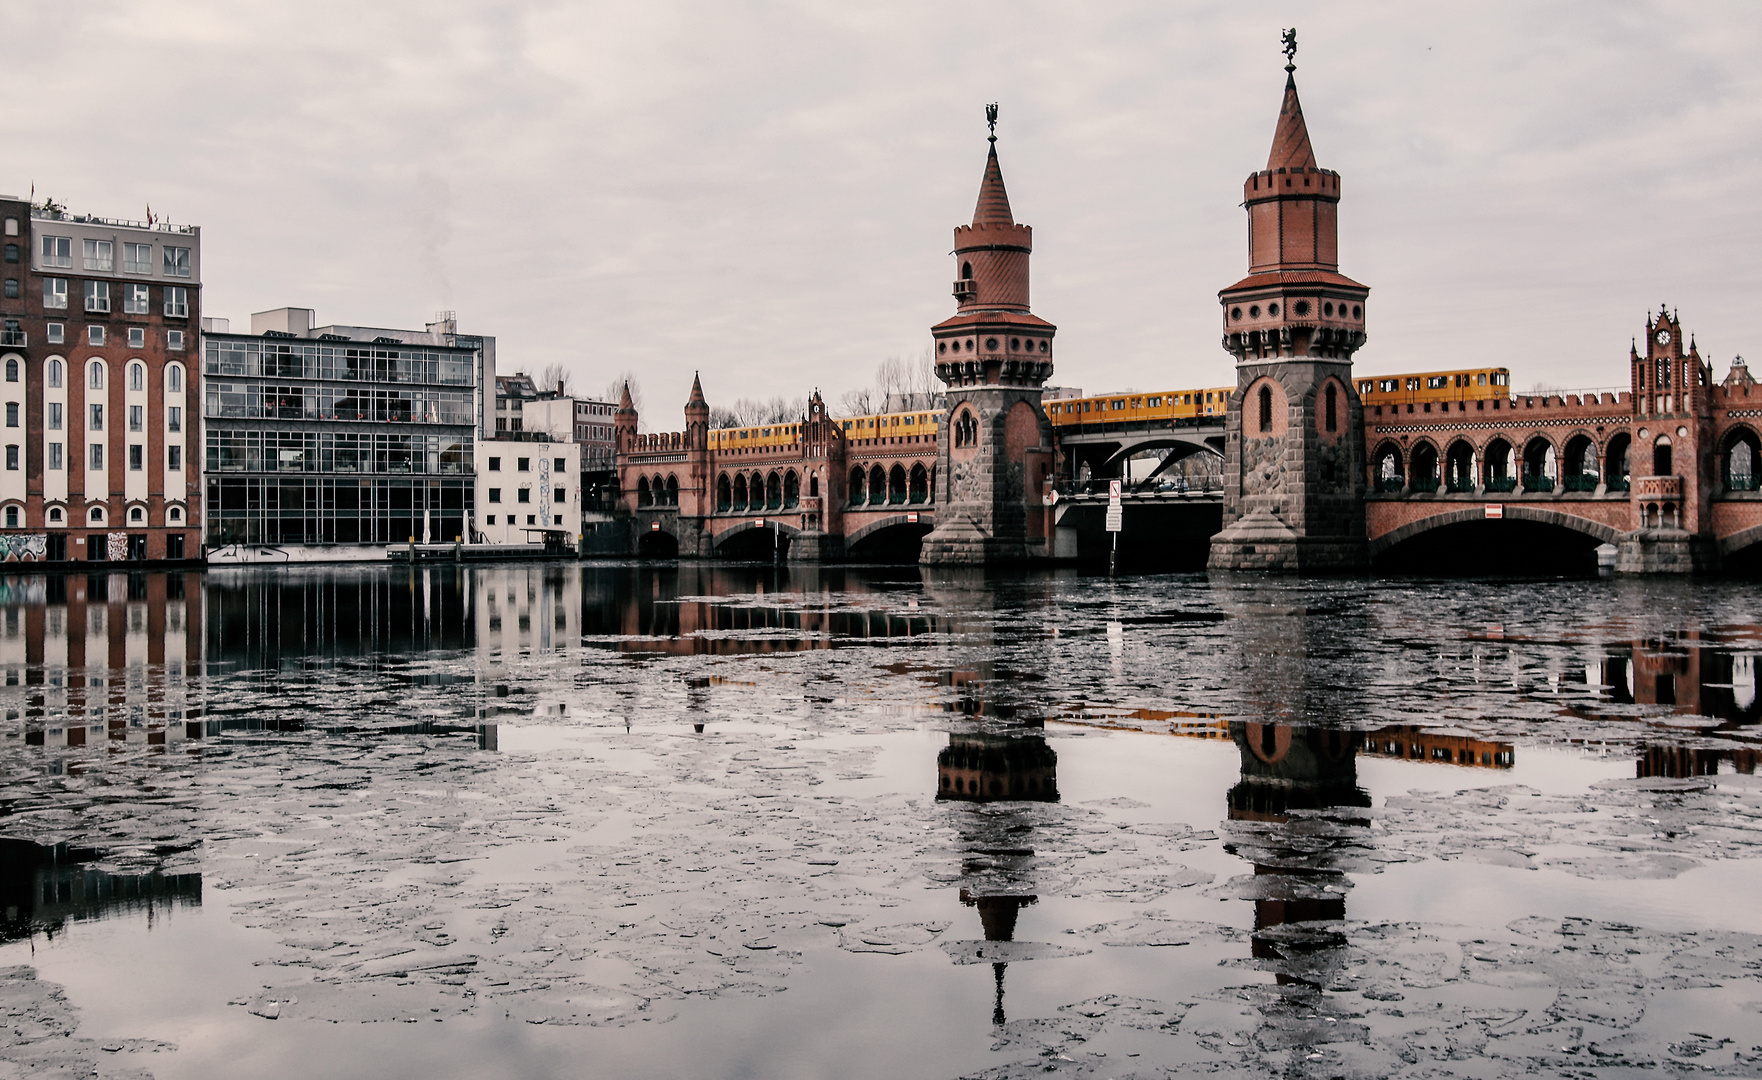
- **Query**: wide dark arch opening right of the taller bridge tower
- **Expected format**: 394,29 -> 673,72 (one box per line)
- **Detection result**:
1373,507 -> 1603,578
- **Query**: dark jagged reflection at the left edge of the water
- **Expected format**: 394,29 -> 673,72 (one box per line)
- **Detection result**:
0,839 -> 203,941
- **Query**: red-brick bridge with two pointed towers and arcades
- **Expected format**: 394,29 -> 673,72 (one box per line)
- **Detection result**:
615,54 -> 1762,573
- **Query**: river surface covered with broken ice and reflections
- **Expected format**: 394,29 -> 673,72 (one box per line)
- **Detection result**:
0,564 -> 1762,1080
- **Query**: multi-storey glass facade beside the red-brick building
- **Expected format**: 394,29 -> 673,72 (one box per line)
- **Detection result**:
203,335 -> 478,544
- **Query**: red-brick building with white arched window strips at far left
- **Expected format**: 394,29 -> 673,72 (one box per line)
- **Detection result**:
0,196 -> 203,562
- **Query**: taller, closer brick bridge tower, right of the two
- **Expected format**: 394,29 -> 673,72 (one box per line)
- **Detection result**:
1210,48 -> 1371,571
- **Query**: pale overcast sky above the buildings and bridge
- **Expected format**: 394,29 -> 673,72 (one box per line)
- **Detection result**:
0,0 -> 1762,414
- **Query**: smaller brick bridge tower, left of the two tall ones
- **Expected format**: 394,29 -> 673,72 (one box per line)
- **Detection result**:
920,106 -> 1057,566
